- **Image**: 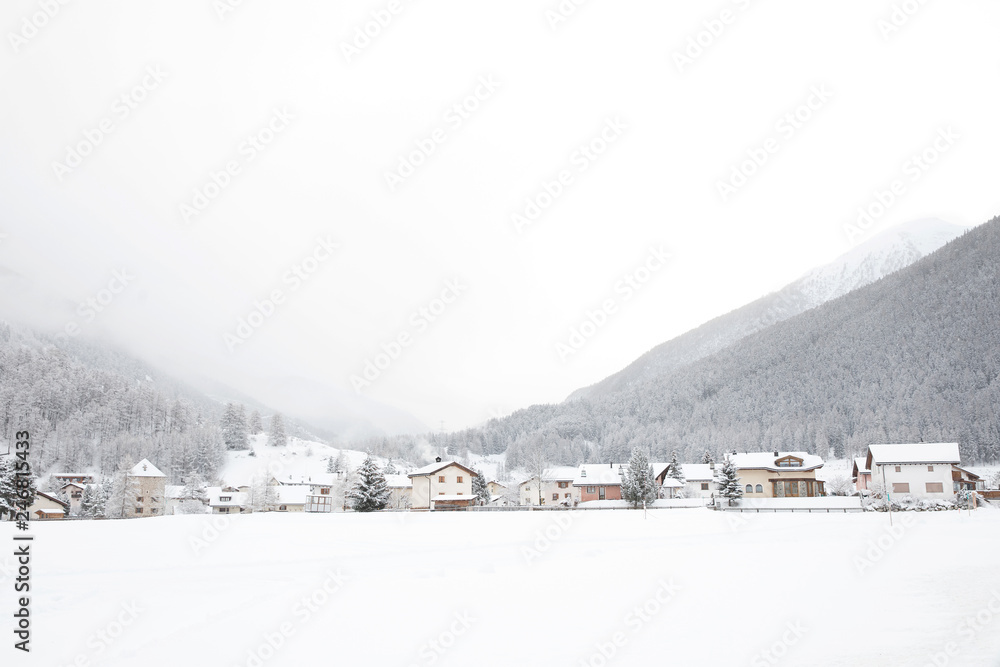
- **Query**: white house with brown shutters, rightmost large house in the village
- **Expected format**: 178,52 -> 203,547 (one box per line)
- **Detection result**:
865,442 -> 975,499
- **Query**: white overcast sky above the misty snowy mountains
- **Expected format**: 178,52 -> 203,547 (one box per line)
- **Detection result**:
0,0 -> 1000,429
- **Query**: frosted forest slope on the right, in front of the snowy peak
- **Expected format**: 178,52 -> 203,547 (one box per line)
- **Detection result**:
450,219 -> 1000,468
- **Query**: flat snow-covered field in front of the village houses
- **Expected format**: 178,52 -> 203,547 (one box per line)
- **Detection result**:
0,509 -> 1000,667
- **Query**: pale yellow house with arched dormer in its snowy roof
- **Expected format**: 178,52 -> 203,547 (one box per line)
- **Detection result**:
730,452 -> 826,498
